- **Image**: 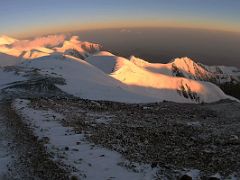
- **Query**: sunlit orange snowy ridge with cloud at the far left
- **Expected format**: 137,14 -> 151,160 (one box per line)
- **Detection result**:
0,35 -> 101,59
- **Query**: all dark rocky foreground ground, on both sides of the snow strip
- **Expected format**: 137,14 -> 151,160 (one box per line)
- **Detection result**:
0,73 -> 240,179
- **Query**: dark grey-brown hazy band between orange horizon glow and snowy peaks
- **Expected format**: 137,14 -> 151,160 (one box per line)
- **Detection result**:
75,28 -> 240,67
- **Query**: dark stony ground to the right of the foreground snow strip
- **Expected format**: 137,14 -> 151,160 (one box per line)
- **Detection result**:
31,98 -> 240,179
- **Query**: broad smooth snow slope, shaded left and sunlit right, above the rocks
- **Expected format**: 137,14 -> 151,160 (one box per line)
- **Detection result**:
22,55 -> 234,103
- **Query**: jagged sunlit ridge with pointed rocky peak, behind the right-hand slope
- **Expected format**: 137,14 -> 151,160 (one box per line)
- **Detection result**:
130,57 -> 240,84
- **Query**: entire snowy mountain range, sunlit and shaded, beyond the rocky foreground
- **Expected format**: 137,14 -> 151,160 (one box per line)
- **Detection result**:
0,36 -> 240,103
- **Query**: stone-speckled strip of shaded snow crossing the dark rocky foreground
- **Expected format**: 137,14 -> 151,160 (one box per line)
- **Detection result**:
13,99 -> 156,180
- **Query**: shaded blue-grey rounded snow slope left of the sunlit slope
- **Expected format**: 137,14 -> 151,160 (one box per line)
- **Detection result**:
21,55 -> 154,103
